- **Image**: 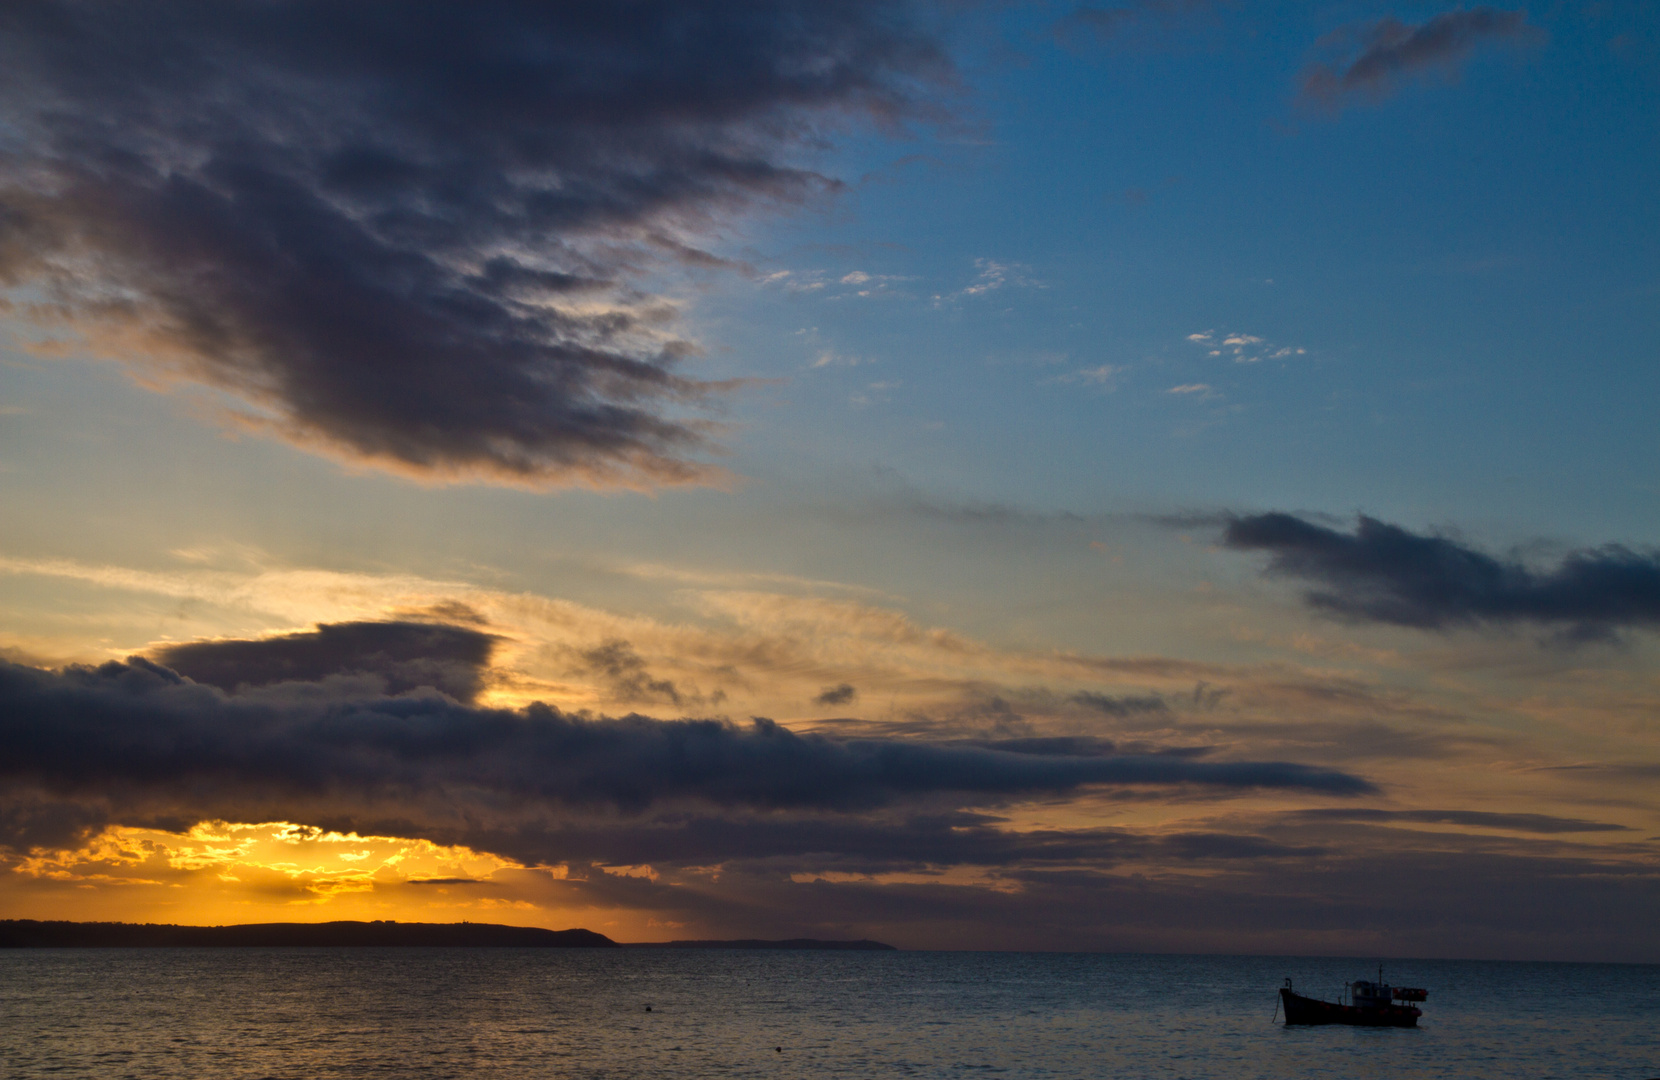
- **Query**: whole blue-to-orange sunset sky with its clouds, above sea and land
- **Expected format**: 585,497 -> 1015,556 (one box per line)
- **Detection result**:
0,0 -> 1660,962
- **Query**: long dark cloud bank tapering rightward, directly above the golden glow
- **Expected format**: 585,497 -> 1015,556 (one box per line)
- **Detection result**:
0,657 -> 1373,858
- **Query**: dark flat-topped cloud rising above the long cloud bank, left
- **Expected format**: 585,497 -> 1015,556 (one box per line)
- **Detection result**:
154,622 -> 496,702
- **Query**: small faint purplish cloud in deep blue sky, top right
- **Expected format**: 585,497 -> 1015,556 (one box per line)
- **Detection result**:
1301,7 -> 1540,108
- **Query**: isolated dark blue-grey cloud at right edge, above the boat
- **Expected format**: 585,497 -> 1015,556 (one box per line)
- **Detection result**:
1223,513 -> 1660,637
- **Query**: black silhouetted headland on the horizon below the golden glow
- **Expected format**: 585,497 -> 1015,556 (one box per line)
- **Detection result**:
0,919 -> 618,949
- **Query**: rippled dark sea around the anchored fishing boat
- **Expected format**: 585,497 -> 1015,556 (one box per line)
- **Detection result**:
0,949 -> 1660,1080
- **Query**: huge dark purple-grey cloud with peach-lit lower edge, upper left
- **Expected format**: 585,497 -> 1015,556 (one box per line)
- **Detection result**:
0,0 -> 950,484
